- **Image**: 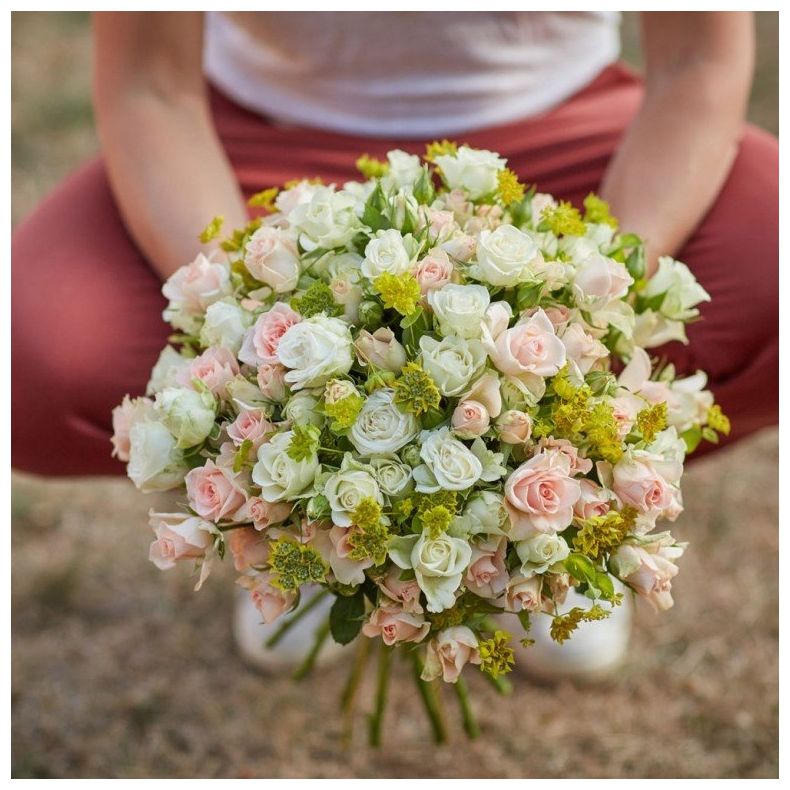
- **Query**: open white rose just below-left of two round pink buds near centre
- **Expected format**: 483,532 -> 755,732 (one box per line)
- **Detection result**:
414,428 -> 483,494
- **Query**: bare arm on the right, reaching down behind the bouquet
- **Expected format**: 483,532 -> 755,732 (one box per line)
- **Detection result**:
601,11 -> 754,272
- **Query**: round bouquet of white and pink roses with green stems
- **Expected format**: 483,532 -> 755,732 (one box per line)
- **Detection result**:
113,141 -> 729,742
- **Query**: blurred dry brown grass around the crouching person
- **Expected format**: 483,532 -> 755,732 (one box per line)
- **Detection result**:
11,12 -> 779,778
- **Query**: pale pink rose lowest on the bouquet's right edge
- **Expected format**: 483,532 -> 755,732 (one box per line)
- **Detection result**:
612,543 -> 683,611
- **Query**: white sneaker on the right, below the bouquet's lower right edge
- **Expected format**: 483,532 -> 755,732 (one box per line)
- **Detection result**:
503,588 -> 633,683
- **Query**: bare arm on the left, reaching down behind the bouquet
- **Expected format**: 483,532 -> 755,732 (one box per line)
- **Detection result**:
94,12 -> 246,278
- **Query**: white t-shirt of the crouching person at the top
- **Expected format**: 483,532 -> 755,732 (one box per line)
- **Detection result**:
204,11 -> 620,138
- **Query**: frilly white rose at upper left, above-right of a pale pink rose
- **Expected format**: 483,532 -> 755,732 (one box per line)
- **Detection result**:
288,186 -> 360,252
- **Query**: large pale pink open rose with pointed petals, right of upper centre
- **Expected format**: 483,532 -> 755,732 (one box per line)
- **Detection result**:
482,310 -> 565,376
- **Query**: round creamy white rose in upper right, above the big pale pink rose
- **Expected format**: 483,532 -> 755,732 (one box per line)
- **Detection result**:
472,225 -> 543,288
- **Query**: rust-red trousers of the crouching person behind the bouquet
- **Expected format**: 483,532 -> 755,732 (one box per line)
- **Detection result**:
12,66 -> 779,475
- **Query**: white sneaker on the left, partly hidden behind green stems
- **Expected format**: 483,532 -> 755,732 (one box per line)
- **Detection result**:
233,587 -> 345,672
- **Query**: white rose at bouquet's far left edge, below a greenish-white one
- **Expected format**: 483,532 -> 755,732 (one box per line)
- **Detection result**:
126,420 -> 187,493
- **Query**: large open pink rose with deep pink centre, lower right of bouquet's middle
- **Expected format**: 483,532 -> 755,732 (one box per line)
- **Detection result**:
505,450 -> 581,540
